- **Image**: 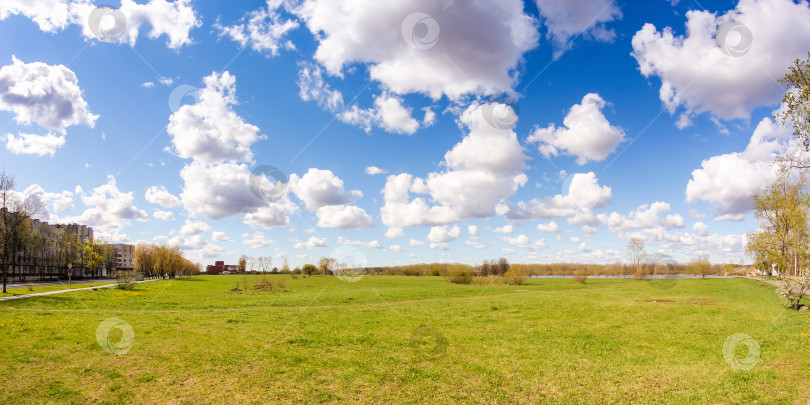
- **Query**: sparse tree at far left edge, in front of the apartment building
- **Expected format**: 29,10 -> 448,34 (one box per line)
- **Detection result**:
0,170 -> 42,293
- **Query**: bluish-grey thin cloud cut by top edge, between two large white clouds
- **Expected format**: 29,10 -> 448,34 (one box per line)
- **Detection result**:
537,0 -> 622,56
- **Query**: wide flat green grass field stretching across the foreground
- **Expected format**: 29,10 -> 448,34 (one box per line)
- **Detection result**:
0,276 -> 810,404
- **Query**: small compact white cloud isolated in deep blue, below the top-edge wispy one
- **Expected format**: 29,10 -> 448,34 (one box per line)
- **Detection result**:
527,93 -> 624,165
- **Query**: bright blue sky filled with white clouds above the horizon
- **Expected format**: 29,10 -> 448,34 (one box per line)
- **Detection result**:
0,0 -> 810,266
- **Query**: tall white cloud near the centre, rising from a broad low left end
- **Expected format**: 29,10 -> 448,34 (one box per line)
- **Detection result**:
380,104 -> 527,228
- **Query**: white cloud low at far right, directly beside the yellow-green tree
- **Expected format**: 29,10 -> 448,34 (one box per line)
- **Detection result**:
686,113 -> 792,221
